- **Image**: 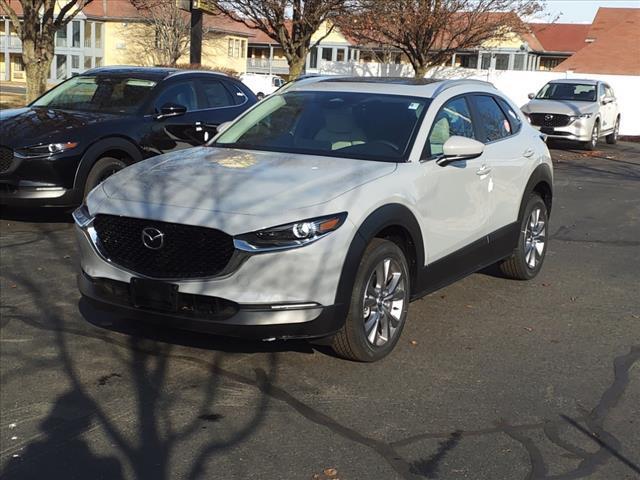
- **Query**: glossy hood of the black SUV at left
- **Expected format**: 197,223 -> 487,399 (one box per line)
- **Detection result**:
0,107 -> 121,148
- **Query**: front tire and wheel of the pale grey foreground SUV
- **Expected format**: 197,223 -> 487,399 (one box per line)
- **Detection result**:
331,238 -> 411,362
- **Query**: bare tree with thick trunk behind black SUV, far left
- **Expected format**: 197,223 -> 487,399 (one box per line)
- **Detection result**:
0,0 -> 92,102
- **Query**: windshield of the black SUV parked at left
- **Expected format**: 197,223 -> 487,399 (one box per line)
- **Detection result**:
31,76 -> 156,114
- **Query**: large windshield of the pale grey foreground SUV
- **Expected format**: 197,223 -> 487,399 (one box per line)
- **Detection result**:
213,91 -> 430,162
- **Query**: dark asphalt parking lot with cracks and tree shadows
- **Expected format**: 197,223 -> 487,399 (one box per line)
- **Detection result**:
0,143 -> 640,480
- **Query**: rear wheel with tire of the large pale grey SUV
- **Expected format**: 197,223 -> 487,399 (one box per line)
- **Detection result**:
498,193 -> 549,280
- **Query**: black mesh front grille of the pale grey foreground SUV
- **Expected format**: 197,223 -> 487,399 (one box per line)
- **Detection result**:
93,215 -> 234,279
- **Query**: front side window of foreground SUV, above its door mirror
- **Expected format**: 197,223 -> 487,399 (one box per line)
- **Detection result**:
429,97 -> 474,156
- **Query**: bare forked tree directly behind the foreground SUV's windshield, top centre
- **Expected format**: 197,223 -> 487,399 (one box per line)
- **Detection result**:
218,0 -> 352,79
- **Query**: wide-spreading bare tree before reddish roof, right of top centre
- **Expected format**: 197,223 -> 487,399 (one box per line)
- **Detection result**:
338,0 -> 543,77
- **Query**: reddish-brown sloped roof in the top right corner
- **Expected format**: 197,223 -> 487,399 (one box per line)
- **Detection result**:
554,8 -> 640,75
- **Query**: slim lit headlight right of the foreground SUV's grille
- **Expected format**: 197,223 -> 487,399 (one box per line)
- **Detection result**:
234,212 -> 347,252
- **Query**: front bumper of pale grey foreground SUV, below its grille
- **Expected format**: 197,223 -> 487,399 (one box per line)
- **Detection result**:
75,213 -> 353,338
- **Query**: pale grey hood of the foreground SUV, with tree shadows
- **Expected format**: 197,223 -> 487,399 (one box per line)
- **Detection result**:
102,147 -> 396,215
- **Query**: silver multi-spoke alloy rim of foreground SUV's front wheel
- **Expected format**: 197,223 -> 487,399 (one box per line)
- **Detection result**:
362,258 -> 407,347
